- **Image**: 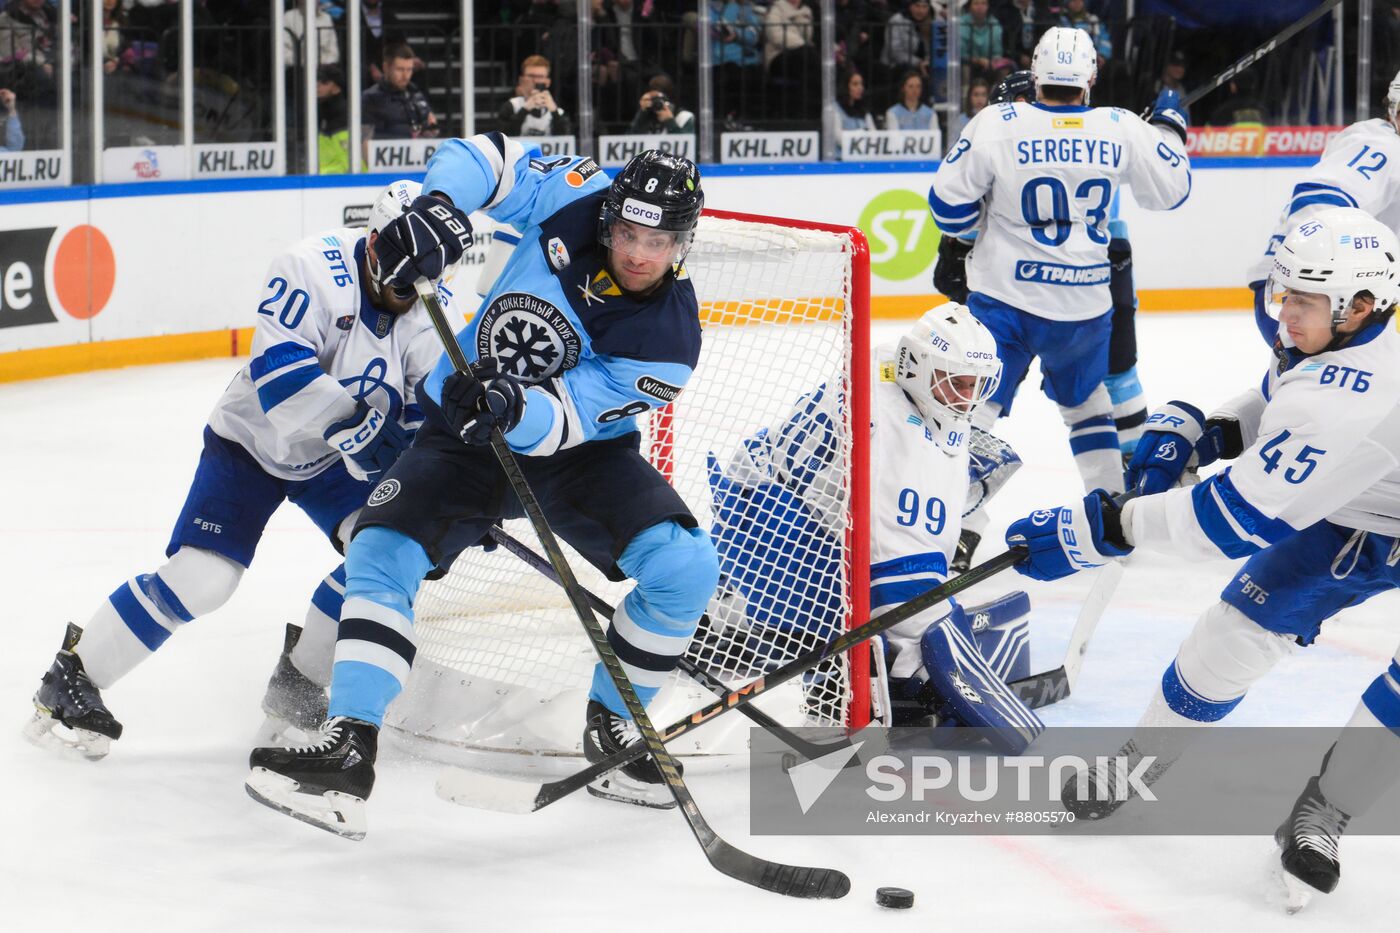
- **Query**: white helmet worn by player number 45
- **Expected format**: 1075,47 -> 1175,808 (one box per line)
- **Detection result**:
1264,207 -> 1400,325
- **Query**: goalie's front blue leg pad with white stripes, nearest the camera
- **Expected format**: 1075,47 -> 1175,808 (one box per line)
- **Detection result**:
920,619 -> 1044,755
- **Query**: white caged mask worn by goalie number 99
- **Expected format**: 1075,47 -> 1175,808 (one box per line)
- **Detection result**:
895,303 -> 1001,426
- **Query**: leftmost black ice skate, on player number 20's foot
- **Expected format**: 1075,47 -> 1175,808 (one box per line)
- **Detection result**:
24,622 -> 122,761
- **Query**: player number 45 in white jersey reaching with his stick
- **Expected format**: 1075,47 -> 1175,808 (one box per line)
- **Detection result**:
1007,207 -> 1400,905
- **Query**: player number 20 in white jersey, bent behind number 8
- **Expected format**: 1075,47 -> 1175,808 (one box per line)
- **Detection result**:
25,181 -> 451,759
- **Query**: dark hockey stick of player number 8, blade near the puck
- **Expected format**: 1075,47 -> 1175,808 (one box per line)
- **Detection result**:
417,279 -> 851,898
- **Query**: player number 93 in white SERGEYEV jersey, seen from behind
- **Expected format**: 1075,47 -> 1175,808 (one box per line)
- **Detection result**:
928,28 -> 1191,563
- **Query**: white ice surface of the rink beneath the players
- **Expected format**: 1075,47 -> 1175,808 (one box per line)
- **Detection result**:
0,314 -> 1400,933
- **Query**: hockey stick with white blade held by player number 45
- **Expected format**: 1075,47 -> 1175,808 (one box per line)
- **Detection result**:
440,548 -> 1026,813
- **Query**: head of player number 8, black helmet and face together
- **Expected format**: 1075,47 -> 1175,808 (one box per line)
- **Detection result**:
598,148 -> 704,265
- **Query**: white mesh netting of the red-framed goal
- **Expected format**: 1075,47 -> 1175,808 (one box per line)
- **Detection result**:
388,216 -> 868,756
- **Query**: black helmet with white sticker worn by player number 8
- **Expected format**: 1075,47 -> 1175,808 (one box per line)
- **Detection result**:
598,148 -> 704,262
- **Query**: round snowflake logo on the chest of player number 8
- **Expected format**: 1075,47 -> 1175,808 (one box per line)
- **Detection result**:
476,291 -> 582,382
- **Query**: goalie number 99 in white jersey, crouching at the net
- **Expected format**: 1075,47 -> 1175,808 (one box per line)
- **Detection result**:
706,303 -> 1043,754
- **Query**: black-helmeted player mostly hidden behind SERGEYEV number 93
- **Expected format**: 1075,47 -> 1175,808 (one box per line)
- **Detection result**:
934,71 -> 1147,573
